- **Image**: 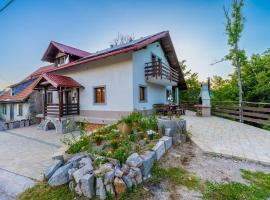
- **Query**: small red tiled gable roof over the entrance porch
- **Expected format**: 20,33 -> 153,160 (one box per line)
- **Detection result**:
34,73 -> 83,88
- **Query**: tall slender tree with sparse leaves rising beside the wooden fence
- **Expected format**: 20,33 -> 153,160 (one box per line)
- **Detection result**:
224,0 -> 246,122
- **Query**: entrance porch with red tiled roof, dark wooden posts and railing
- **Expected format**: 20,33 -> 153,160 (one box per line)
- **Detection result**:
33,73 -> 84,120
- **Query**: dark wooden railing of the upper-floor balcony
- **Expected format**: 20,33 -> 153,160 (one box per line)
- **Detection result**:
144,61 -> 179,83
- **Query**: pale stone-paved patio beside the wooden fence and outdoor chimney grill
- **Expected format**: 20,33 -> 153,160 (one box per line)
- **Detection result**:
183,111 -> 270,165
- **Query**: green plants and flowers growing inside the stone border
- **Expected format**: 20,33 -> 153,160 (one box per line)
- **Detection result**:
64,112 -> 161,163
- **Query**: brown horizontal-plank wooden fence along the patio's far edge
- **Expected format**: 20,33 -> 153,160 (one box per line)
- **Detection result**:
212,101 -> 270,126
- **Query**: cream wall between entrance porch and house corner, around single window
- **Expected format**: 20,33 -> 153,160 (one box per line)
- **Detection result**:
57,53 -> 133,111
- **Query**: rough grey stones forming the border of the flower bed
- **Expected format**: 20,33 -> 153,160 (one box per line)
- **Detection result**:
44,119 -> 186,200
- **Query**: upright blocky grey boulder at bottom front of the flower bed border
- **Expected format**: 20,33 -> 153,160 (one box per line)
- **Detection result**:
80,174 -> 95,199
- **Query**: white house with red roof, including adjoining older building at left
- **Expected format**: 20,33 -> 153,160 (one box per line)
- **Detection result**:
0,31 -> 186,132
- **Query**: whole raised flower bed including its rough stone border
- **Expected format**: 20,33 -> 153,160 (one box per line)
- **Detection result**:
44,112 -> 182,199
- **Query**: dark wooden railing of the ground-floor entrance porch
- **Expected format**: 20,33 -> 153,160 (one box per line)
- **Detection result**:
45,103 -> 80,117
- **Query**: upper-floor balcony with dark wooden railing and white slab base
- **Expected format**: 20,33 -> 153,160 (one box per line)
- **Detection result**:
144,61 -> 179,86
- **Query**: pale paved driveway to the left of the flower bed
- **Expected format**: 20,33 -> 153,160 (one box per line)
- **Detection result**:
0,126 -> 67,200
